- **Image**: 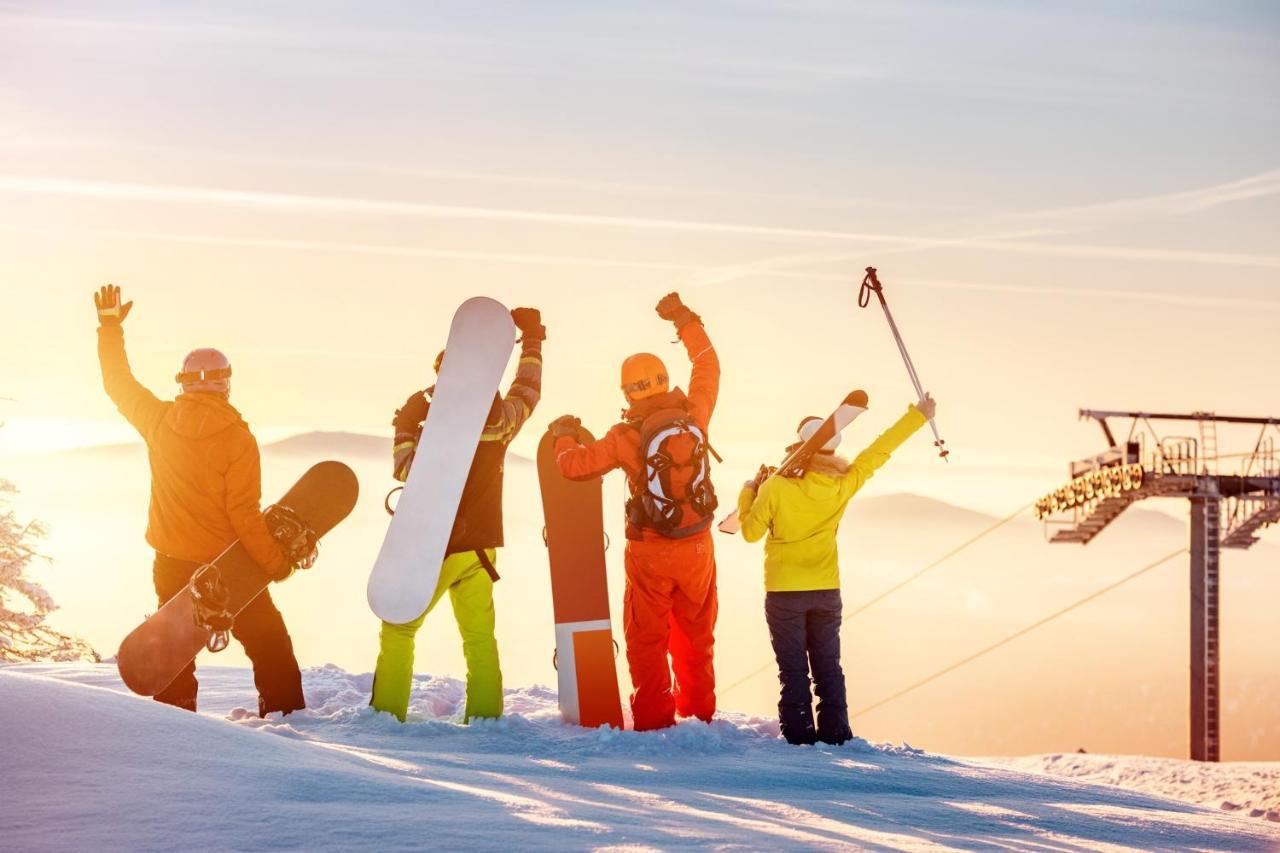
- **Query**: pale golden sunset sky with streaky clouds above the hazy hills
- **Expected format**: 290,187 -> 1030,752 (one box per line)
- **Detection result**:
0,0 -> 1280,753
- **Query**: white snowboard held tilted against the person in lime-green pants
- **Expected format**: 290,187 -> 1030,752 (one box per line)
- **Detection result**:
369,296 -> 516,625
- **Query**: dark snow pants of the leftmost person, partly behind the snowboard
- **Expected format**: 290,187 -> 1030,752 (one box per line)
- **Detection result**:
151,553 -> 306,717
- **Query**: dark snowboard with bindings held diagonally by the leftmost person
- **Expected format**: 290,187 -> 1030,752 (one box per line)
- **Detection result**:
115,461 -> 360,695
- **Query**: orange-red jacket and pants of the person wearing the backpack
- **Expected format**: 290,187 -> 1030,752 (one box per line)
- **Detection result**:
556,315 -> 721,731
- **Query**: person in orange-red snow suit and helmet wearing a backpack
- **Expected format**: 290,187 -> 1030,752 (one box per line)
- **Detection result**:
550,293 -> 721,731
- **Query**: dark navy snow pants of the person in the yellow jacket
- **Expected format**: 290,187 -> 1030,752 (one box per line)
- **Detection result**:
764,589 -> 854,744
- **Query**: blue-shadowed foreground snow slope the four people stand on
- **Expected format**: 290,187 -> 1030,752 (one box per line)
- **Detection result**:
0,665 -> 1280,850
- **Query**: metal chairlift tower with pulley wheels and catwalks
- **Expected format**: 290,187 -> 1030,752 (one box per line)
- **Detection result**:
1036,409 -> 1280,761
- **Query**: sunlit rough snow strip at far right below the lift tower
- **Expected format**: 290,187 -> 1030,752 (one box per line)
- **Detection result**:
992,754 -> 1280,822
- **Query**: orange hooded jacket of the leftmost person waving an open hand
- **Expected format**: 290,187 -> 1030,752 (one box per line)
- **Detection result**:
97,327 -> 284,569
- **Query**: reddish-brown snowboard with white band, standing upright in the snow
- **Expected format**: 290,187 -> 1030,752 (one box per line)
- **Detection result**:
538,429 -> 623,729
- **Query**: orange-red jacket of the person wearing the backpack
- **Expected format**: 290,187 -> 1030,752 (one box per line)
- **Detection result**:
556,320 -> 721,540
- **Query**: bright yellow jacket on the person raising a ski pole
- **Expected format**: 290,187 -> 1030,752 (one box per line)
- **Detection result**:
737,406 -> 925,592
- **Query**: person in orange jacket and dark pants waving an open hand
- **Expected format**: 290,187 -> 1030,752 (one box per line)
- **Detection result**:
93,284 -> 306,716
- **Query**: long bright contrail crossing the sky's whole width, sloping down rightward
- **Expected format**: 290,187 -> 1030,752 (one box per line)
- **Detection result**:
0,177 -> 1280,268
